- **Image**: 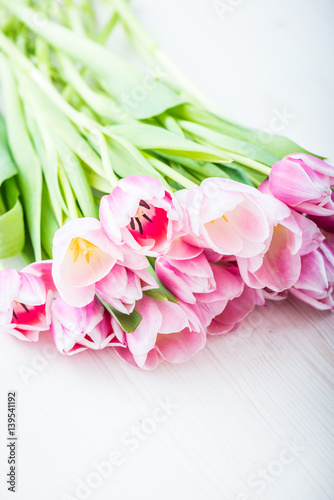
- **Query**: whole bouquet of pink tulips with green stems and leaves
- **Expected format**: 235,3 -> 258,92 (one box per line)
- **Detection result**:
0,0 -> 334,369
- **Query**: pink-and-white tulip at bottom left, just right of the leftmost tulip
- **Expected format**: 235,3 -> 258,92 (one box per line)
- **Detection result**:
50,297 -> 119,354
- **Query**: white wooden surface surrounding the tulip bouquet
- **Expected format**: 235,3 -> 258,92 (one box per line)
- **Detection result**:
0,0 -> 334,500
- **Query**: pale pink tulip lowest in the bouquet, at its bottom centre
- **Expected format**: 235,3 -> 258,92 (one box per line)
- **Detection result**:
114,296 -> 206,370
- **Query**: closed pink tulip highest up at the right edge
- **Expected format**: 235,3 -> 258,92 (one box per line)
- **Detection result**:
269,153 -> 334,216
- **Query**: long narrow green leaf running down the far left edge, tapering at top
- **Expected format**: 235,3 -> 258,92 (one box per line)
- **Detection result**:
0,55 -> 42,261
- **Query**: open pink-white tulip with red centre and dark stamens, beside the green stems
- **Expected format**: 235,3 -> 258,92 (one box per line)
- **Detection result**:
100,175 -> 183,257
